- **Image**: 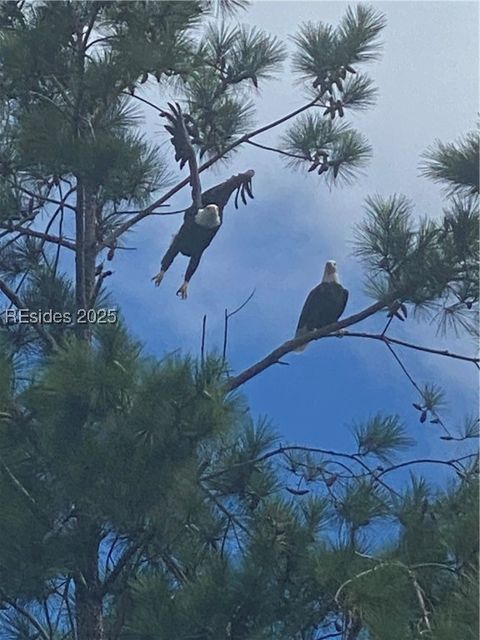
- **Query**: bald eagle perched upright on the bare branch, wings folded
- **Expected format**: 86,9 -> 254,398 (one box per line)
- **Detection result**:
295,260 -> 348,351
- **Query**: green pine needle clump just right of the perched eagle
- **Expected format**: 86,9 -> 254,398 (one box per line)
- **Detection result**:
356,196 -> 479,332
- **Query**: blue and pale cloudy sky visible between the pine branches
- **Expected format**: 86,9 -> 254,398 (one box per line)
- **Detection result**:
108,1 -> 478,484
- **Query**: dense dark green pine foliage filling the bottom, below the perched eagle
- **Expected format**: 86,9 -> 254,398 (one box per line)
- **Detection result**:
0,332 -> 478,640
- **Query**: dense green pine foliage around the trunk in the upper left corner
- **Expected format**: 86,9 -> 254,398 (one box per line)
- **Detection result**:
0,2 -> 197,203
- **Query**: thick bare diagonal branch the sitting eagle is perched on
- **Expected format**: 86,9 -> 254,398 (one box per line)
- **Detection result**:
225,300 -> 388,391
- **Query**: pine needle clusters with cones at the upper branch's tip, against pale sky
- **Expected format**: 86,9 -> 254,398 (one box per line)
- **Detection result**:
282,5 -> 385,184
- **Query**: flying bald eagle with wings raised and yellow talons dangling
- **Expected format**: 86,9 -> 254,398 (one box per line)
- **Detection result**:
152,104 -> 254,300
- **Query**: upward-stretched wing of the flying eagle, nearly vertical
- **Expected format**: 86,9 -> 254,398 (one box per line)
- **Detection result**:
161,102 -> 202,213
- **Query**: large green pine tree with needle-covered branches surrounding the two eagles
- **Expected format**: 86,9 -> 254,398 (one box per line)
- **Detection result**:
0,0 -> 479,640
